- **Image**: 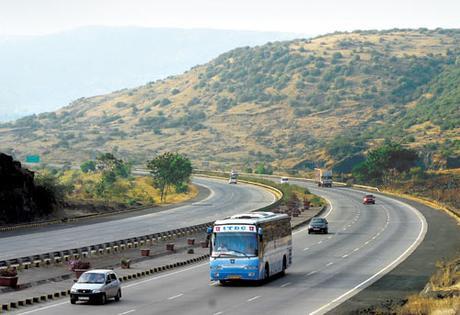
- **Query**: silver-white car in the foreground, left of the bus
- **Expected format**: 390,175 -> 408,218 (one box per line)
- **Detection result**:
70,269 -> 121,304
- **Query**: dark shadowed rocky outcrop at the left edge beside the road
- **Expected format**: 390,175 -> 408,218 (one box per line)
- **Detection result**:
0,153 -> 54,225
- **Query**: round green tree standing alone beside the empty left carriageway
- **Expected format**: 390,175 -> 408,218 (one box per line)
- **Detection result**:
147,152 -> 192,202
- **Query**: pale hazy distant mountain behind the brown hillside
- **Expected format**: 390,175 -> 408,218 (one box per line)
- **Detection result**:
0,27 -> 302,121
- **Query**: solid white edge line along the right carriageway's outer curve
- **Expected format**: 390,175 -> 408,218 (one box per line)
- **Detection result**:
310,196 -> 427,315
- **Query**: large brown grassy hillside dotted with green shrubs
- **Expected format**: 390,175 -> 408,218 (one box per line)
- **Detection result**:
0,29 -> 460,169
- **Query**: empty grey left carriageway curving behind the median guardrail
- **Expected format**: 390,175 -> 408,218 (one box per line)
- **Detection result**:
0,178 -> 275,260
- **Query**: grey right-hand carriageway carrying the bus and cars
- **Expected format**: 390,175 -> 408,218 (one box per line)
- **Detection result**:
11,182 -> 427,315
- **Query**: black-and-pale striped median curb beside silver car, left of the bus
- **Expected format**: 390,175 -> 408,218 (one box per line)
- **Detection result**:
0,254 -> 209,313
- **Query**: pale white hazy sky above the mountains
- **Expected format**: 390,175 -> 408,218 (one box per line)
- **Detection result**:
0,0 -> 460,35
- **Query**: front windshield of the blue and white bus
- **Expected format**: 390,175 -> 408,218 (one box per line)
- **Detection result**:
212,232 -> 257,257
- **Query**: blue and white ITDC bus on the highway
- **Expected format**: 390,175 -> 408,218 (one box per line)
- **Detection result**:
208,212 -> 292,284
